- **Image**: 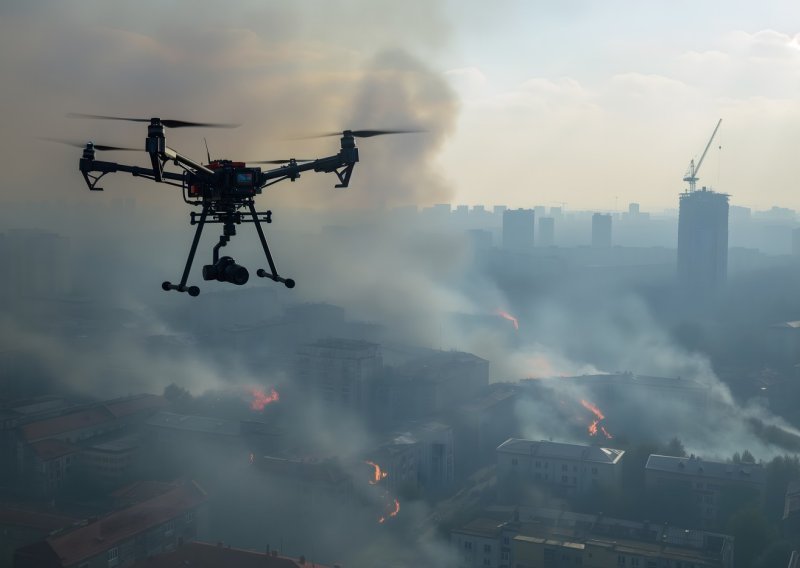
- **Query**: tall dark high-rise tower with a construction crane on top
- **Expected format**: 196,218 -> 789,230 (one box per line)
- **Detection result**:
678,187 -> 728,292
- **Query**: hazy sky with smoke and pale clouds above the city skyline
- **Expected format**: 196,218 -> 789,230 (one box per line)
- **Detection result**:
0,0 -> 800,211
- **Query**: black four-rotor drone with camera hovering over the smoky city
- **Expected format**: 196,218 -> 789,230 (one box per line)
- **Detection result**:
56,113 -> 420,296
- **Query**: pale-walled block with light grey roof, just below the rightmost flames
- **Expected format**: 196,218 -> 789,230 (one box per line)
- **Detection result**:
497,438 -> 625,492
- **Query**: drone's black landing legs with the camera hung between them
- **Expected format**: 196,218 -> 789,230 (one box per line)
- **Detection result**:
161,202 -> 295,296
